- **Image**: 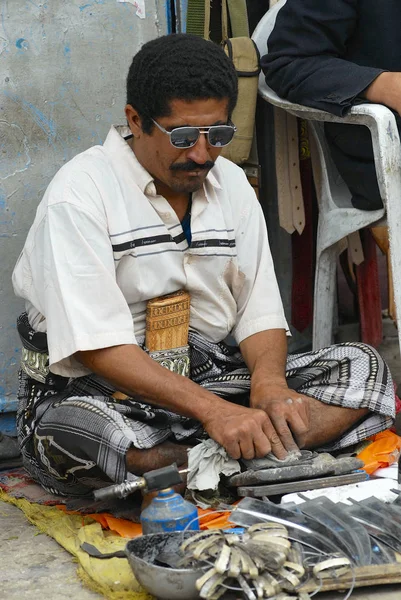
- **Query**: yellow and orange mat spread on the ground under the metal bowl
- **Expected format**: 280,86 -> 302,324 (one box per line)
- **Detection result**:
0,469 -> 228,600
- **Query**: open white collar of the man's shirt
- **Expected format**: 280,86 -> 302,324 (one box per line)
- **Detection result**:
103,125 -> 221,196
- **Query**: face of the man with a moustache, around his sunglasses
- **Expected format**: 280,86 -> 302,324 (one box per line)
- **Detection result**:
125,98 -> 228,194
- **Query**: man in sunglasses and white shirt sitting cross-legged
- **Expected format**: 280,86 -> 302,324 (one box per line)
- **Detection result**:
13,34 -> 394,495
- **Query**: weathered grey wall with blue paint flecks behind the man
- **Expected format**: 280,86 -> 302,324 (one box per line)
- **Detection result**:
0,0 -> 167,432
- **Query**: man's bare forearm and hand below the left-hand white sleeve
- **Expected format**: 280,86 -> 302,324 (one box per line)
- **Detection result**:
75,344 -> 287,459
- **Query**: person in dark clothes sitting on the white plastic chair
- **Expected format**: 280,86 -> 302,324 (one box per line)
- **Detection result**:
262,0 -> 401,210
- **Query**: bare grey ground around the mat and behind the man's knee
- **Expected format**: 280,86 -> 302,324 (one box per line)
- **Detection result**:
0,322 -> 401,600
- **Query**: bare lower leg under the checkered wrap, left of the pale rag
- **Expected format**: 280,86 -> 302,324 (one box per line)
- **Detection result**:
126,442 -> 189,476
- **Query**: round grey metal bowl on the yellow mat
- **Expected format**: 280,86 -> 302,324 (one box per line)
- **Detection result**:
125,531 -> 204,600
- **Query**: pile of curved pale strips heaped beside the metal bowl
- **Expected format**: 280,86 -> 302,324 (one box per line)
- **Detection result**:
181,523 -> 322,600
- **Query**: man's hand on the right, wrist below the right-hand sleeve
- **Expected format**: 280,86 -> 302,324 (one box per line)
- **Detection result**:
250,382 -> 309,452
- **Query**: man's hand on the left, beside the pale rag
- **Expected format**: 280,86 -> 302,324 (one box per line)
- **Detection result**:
203,402 -> 287,460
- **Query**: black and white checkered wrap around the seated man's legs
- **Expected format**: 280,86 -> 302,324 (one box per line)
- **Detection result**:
17,333 -> 395,496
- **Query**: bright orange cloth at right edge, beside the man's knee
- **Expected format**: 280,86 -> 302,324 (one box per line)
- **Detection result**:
357,429 -> 401,475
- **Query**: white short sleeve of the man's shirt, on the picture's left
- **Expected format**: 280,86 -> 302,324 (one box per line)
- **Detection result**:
30,176 -> 136,375
